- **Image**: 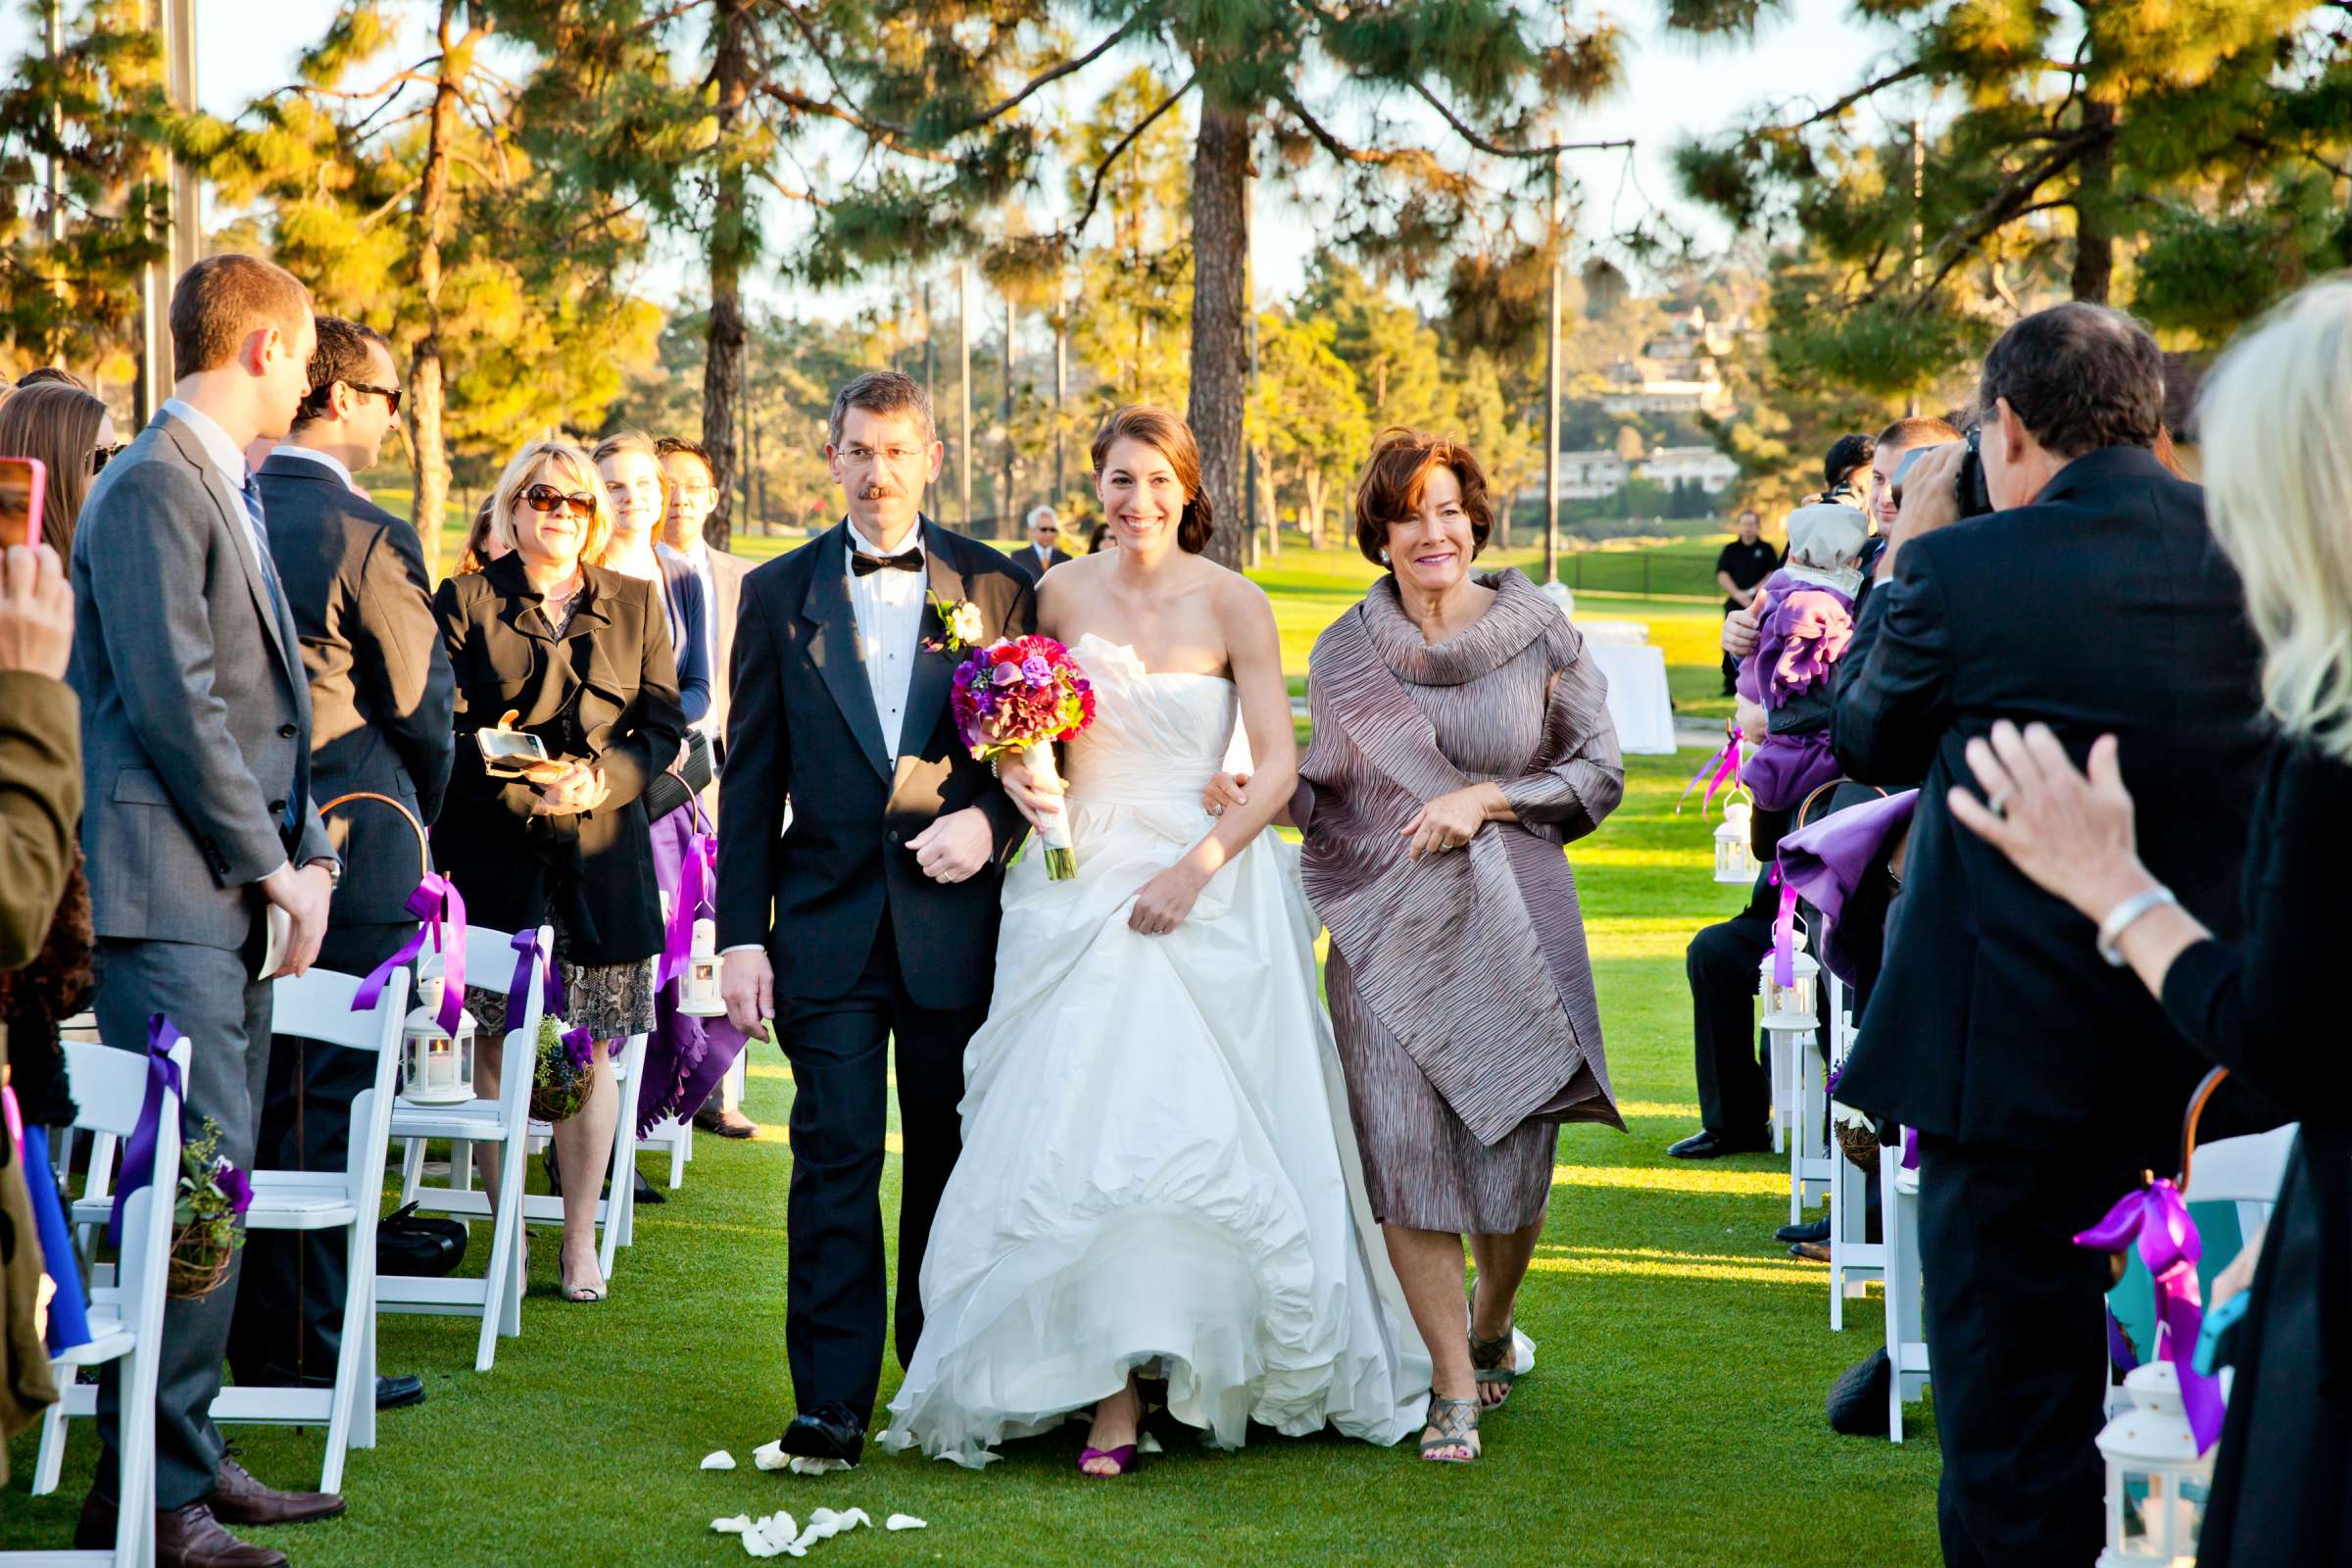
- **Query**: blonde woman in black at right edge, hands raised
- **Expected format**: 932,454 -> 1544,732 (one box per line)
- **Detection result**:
1950,279 -> 2352,1568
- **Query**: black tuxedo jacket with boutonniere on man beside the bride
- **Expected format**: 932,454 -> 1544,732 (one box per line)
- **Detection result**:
717,519 -> 1037,1008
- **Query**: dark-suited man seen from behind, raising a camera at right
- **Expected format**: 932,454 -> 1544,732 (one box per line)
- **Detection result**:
1833,303 -> 2265,1568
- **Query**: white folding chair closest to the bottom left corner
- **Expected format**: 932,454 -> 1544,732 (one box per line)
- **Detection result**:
19,1037 -> 193,1568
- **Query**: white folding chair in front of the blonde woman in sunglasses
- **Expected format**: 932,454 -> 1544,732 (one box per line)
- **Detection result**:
376,926 -> 555,1373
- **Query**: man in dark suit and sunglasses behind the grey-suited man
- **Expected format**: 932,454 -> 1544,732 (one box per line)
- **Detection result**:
228,315 -> 452,1408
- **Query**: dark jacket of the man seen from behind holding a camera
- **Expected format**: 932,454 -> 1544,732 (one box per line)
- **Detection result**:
1833,447 -> 2270,1168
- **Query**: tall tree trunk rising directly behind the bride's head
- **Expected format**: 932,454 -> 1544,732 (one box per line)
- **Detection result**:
1186,96 -> 1249,571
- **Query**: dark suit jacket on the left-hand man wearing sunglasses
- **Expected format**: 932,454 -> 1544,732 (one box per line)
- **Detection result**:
257,449 -> 457,926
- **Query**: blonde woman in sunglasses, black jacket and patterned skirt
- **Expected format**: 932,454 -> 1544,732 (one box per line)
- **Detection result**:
433,442 -> 684,1302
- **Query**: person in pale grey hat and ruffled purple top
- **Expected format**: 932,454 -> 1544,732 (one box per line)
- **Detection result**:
1739,501 -> 1870,811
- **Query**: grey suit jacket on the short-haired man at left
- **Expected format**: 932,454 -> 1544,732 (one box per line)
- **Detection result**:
69,414 -> 334,948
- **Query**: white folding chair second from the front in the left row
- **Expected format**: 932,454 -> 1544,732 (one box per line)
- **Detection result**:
71,968 -> 410,1493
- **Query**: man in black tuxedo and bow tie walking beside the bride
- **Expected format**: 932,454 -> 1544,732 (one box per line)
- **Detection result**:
717,371 -> 1035,1462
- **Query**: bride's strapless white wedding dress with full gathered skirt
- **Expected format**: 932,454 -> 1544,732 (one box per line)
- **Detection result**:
882,632 -> 1430,1467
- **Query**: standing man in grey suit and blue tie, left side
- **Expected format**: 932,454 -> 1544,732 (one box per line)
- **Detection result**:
73,256 -> 343,1568
